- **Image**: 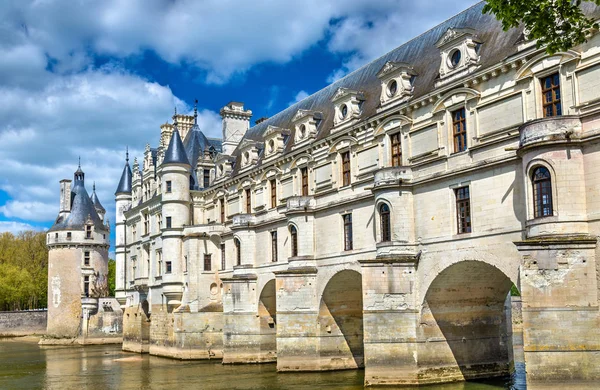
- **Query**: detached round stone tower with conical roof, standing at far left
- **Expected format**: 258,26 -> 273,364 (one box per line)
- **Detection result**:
46,161 -> 110,338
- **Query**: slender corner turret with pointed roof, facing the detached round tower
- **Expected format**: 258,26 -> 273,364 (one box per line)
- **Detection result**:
115,151 -> 132,307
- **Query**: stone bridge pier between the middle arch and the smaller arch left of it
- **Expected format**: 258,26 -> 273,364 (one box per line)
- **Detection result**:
275,267 -> 322,371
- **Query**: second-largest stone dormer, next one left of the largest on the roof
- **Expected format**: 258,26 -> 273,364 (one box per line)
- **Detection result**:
377,61 -> 417,107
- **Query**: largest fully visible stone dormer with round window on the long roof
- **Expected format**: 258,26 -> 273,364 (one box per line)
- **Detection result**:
435,28 -> 481,87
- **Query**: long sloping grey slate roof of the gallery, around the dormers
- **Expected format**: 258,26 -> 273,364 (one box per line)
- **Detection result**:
225,2 -> 600,174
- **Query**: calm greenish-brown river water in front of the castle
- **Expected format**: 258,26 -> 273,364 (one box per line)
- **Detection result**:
0,338 -> 528,390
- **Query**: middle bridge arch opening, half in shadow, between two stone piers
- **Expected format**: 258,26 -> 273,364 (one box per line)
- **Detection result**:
319,270 -> 364,370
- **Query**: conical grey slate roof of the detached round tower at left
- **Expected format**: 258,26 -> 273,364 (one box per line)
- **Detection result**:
49,170 -> 106,232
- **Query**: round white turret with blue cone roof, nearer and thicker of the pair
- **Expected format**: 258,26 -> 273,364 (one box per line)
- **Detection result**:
159,116 -> 191,309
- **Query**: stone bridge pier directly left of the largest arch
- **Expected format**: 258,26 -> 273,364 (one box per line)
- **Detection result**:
360,256 -> 419,385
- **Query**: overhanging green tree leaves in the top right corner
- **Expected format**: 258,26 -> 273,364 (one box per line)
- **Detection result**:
483,0 -> 600,54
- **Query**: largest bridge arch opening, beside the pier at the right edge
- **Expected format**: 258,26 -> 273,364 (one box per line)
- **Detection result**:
419,260 -> 513,380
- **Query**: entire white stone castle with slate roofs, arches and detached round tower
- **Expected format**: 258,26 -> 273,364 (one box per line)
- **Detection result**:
39,3 -> 600,385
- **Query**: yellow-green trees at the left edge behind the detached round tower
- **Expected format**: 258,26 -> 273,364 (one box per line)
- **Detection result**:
0,231 -> 48,310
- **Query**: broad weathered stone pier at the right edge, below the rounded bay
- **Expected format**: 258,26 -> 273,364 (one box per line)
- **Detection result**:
515,236 -> 600,384
